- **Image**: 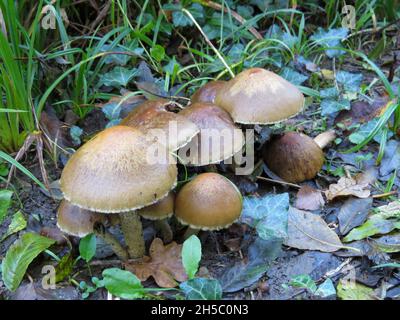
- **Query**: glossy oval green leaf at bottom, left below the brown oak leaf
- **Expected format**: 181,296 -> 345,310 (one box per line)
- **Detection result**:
102,268 -> 146,299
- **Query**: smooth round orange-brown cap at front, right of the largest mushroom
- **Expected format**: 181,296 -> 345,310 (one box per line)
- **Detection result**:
175,173 -> 242,230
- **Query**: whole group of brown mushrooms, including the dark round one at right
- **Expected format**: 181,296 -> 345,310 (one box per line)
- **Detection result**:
57,68 -> 329,260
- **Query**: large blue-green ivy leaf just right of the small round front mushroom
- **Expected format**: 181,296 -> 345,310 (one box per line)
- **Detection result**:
241,193 -> 289,240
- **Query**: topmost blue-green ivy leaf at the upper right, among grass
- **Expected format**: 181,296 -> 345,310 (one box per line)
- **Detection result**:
311,28 -> 349,58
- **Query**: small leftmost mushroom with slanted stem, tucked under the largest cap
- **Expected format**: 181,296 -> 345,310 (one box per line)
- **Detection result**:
57,199 -> 128,260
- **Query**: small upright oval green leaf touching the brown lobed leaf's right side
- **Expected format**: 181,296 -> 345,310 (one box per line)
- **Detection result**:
182,235 -> 201,279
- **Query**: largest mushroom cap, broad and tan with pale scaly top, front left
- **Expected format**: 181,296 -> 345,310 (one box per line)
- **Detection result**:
60,126 -> 177,213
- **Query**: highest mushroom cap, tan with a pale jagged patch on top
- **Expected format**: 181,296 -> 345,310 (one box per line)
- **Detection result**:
215,68 -> 304,124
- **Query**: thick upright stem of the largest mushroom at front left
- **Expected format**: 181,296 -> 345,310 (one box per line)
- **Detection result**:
119,211 -> 145,259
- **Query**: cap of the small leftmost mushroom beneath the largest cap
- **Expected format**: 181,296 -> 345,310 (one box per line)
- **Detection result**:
57,199 -> 106,238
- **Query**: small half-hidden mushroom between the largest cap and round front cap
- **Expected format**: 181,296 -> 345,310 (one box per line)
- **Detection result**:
137,191 -> 175,243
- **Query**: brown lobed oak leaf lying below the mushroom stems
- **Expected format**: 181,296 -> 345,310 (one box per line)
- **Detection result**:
125,238 -> 187,288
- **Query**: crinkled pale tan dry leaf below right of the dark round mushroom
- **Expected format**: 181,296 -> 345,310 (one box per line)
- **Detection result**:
325,177 -> 371,201
